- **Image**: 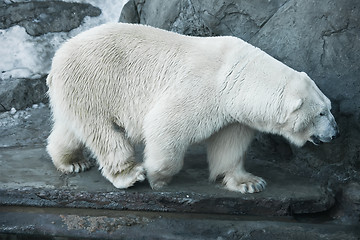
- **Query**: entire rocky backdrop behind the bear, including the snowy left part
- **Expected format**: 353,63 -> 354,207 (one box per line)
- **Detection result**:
0,0 -> 360,214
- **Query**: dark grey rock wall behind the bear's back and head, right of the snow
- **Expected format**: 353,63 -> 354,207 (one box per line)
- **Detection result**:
120,0 -> 360,183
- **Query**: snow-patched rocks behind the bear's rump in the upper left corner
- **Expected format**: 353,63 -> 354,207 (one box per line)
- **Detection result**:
0,0 -> 126,112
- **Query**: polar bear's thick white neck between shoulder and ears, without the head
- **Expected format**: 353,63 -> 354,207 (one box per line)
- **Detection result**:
221,45 -> 295,133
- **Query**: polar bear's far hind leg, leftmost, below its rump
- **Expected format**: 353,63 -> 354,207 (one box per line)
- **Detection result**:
46,122 -> 91,173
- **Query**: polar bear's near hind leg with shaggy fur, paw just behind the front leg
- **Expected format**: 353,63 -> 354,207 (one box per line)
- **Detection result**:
86,122 -> 145,189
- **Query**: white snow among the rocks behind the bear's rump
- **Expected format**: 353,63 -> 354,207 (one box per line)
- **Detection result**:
0,0 -> 128,80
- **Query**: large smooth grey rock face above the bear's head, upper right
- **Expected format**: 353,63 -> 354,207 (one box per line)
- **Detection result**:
250,0 -> 360,115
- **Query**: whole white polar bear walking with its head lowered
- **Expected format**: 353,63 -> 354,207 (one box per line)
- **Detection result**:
47,23 -> 338,193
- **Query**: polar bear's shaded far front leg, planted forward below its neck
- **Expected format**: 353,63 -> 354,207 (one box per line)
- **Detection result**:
207,123 -> 266,193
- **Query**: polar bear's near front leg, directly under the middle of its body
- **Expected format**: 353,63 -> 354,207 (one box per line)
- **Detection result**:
144,99 -> 190,189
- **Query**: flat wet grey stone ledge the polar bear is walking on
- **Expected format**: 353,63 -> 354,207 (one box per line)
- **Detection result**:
0,146 -> 334,216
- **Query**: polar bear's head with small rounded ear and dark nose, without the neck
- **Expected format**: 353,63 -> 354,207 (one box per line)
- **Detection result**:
278,72 -> 339,146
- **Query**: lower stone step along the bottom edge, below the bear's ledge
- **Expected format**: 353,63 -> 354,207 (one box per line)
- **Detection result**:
0,207 -> 360,240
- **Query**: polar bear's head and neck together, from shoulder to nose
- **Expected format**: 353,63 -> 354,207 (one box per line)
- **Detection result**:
221,49 -> 339,146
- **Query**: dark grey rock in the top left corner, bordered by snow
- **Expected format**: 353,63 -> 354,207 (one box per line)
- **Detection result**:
0,1 -> 101,36
